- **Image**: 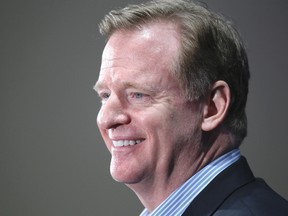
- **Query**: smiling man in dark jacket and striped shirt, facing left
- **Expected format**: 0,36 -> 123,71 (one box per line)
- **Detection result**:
95,0 -> 288,216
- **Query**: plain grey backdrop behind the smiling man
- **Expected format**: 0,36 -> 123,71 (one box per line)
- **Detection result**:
0,0 -> 288,216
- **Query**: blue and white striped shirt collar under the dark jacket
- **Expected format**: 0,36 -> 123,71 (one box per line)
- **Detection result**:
140,149 -> 240,216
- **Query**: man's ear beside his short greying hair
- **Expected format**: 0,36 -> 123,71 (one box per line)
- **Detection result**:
201,80 -> 231,131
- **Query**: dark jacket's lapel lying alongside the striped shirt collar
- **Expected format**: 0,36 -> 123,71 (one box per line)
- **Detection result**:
183,157 -> 255,216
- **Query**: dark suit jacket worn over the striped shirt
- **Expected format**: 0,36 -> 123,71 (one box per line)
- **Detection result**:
183,157 -> 288,216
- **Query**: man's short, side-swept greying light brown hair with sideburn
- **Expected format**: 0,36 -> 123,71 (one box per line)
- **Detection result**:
99,0 -> 250,145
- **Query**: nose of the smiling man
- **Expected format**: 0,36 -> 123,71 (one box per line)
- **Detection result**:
97,95 -> 131,129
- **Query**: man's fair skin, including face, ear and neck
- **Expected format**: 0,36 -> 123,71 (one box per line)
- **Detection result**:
95,19 -> 230,211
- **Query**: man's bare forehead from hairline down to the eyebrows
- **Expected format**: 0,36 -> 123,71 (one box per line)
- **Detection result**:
96,22 -> 179,91
